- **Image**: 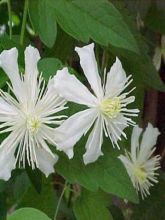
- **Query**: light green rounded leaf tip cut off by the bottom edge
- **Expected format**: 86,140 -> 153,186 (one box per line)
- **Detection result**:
7,208 -> 50,220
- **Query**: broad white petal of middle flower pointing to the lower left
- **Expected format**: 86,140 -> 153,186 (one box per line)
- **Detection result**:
55,109 -> 97,158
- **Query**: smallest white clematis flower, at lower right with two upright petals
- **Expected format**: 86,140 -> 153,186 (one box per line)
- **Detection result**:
119,123 -> 160,198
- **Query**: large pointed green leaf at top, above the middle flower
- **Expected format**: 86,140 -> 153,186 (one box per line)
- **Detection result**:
47,0 -> 139,53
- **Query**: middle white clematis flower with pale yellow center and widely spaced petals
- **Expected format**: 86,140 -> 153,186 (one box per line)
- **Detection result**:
54,43 -> 139,164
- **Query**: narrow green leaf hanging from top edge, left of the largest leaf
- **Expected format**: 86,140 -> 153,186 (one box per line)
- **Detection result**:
29,0 -> 57,48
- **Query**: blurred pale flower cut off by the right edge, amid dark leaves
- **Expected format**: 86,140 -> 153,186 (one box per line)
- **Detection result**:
153,36 -> 165,71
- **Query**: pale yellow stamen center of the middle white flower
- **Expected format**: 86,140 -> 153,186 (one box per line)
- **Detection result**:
100,97 -> 121,118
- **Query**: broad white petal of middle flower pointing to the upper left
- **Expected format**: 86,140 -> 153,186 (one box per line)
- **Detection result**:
54,68 -> 97,107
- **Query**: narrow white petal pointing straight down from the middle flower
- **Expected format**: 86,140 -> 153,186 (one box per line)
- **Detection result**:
83,117 -> 103,164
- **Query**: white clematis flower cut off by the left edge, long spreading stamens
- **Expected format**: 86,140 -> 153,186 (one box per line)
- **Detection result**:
0,46 -> 65,180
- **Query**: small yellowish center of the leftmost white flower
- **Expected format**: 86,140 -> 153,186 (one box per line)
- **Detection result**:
27,116 -> 41,134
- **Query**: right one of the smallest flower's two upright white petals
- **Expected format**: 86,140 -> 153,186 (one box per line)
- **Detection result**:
139,123 -> 160,161
